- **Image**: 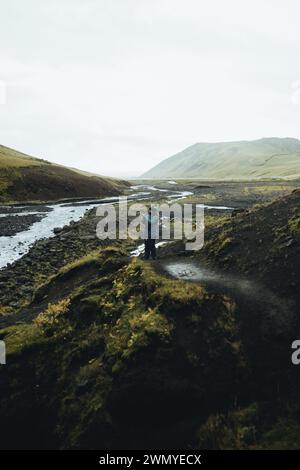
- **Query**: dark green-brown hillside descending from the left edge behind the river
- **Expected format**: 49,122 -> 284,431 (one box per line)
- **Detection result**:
0,145 -> 129,202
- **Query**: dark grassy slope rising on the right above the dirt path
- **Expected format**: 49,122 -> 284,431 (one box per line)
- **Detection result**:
199,189 -> 300,302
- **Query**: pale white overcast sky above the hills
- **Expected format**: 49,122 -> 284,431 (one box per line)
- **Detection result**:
0,0 -> 300,176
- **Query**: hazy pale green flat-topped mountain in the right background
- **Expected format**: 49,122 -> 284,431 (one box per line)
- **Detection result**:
142,137 -> 300,180
